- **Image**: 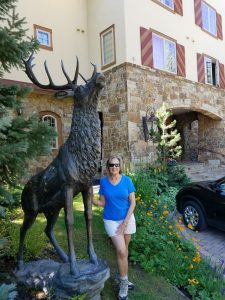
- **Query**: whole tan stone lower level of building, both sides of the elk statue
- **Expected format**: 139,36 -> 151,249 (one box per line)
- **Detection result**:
25,63 -> 225,174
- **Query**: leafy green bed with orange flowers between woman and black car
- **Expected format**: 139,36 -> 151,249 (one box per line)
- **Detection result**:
130,169 -> 225,300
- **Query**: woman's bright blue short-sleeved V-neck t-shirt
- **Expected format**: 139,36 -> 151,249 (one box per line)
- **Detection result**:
99,175 -> 135,221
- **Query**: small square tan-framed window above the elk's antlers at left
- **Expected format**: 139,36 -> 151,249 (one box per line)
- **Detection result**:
34,25 -> 53,51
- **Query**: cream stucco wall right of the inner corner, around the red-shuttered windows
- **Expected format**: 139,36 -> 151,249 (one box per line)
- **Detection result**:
88,0 -> 225,81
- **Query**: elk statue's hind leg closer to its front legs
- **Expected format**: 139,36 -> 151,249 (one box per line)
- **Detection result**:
44,210 -> 69,263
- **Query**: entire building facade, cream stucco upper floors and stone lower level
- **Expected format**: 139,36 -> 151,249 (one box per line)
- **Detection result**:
2,0 -> 225,173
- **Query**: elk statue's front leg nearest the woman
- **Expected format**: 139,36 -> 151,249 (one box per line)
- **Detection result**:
82,186 -> 98,265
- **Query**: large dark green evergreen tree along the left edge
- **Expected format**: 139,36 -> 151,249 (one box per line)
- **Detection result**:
0,0 -> 56,216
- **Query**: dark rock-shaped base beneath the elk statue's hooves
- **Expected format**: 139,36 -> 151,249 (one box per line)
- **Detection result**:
15,259 -> 110,300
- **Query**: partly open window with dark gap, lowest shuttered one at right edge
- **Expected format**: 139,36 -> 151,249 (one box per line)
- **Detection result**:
204,56 -> 219,86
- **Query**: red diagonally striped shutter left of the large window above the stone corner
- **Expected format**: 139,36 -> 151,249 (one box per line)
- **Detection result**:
140,27 -> 153,68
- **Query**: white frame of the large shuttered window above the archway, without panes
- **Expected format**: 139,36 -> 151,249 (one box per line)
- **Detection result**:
152,32 -> 177,74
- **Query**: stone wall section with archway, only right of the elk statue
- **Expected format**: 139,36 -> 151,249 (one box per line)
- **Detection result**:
101,63 -> 225,168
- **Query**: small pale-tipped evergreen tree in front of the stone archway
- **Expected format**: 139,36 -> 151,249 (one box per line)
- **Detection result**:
150,103 -> 182,164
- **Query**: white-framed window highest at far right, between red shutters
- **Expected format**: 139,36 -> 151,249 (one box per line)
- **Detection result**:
202,1 -> 217,36
